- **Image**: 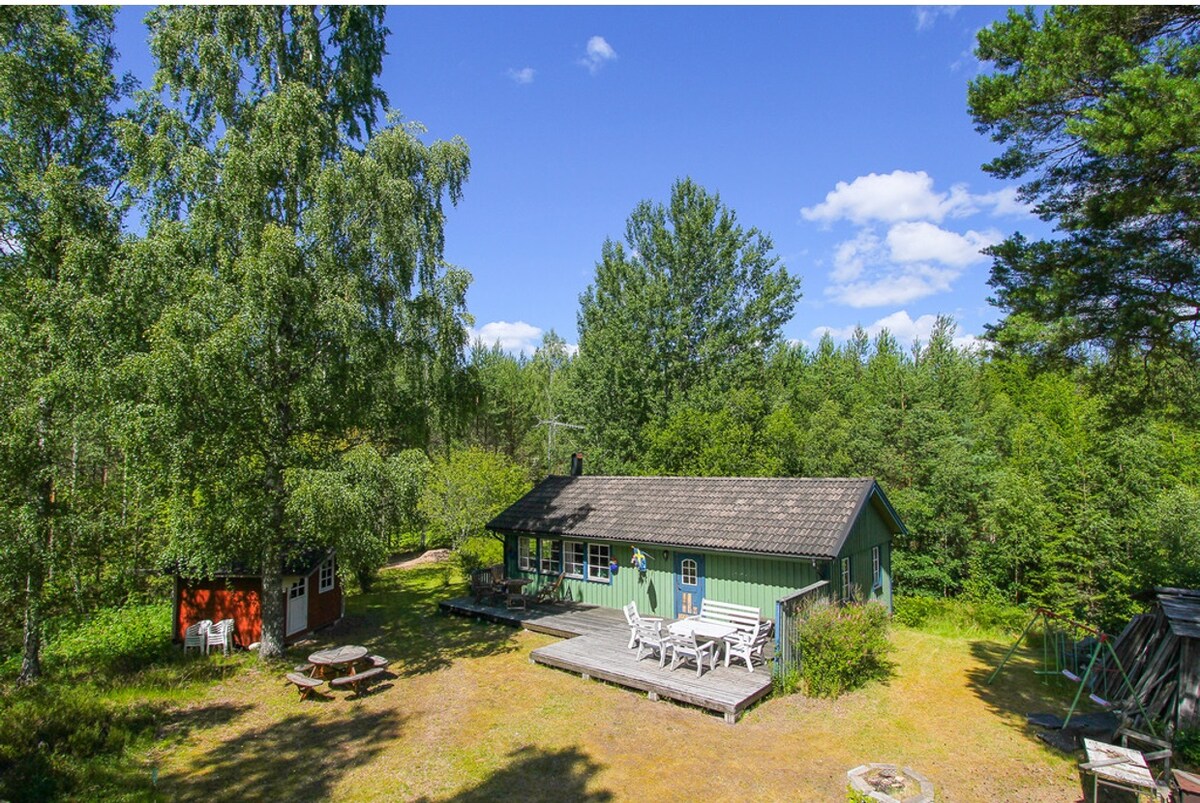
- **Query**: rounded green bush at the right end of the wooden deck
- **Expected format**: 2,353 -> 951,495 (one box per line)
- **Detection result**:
796,600 -> 892,697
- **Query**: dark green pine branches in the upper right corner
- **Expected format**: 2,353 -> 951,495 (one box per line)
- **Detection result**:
968,6 -> 1200,358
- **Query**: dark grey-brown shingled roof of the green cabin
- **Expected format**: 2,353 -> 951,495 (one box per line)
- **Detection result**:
487,477 -> 905,558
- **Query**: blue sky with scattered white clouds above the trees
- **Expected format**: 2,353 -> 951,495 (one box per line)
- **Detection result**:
110,6 -> 1046,350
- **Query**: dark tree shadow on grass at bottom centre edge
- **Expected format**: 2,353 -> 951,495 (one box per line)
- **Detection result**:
420,747 -> 613,803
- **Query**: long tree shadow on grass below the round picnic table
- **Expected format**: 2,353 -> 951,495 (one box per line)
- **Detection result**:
161,711 -> 404,801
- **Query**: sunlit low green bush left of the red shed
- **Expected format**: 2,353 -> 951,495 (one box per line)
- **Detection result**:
43,604 -> 174,672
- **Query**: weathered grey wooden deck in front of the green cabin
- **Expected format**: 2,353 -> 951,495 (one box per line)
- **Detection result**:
439,597 -> 770,723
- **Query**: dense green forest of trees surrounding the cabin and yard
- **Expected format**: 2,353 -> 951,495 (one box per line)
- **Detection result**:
7,7 -> 1200,679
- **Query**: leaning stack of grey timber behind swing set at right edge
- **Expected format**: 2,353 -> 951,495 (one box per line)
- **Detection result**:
1108,588 -> 1200,731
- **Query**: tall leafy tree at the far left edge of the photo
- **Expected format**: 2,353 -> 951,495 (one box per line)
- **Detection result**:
0,6 -> 126,682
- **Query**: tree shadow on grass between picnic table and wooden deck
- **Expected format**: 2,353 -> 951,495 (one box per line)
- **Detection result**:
295,565 -> 517,677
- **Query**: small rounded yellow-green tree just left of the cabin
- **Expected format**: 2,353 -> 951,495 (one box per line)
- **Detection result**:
420,447 -> 532,561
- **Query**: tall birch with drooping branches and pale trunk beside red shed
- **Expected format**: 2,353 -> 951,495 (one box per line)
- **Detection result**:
124,6 -> 469,658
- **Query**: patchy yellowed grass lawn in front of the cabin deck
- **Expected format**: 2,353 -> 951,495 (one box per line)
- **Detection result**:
131,567 -> 1081,802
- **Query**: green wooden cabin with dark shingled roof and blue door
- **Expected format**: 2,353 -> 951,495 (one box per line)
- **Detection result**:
487,475 -> 905,619
